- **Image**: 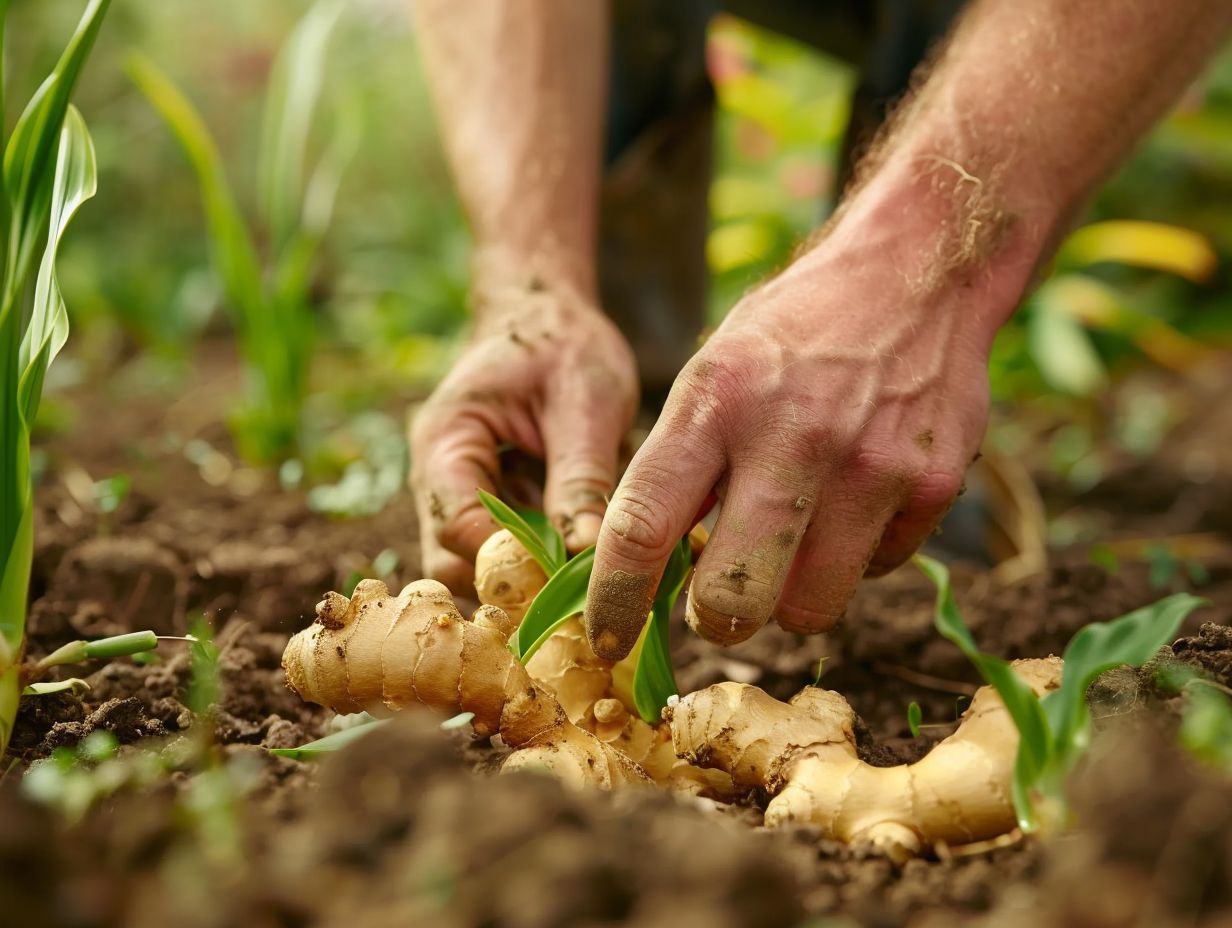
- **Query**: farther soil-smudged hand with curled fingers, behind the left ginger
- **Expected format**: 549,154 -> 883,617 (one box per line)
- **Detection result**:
410,278 -> 637,592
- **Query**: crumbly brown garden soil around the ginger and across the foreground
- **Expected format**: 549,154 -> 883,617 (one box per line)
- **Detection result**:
7,350 -> 1232,928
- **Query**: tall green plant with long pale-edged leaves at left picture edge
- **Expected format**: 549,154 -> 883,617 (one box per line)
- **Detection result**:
0,0 -> 110,755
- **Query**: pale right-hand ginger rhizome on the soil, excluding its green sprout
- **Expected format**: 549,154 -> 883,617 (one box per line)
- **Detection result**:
665,657 -> 1062,861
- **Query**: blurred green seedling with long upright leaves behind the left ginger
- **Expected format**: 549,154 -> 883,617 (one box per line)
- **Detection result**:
128,0 -> 357,465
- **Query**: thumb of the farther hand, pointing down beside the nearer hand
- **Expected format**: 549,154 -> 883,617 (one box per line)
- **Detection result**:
542,396 -> 625,552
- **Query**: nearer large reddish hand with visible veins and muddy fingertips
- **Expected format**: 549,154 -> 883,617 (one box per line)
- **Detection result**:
585,207 -> 1025,659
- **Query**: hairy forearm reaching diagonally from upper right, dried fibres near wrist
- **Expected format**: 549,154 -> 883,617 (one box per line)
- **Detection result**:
806,0 -> 1232,338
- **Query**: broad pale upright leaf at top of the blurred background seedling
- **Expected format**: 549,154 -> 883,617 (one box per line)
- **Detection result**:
257,0 -> 344,253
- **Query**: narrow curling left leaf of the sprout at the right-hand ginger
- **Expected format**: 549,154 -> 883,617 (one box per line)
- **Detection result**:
914,555 -> 1052,831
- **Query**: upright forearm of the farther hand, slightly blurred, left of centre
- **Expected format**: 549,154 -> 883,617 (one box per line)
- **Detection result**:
415,0 -> 607,301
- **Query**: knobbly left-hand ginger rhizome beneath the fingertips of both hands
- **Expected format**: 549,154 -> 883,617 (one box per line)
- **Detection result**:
283,531 -> 694,792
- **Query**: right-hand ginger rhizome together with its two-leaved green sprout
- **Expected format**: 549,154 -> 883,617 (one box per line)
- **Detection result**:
665,557 -> 1202,860
